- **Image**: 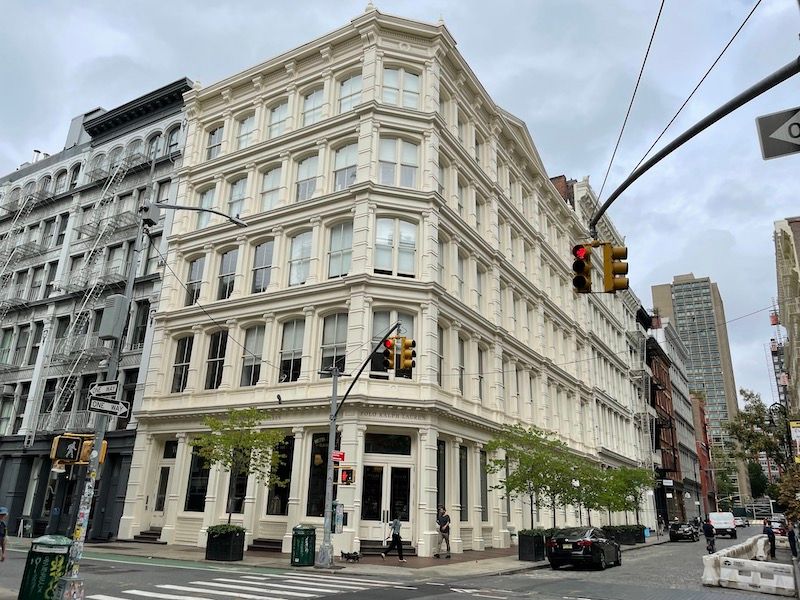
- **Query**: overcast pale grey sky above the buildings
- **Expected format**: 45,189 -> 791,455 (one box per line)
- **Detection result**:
0,0 -> 800,403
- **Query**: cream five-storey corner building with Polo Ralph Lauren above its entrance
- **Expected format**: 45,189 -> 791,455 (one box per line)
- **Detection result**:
120,10 -> 649,556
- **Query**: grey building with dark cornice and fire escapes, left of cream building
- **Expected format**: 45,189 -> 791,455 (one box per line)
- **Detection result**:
0,80 -> 191,539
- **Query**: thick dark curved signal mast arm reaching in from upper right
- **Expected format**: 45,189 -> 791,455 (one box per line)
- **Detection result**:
589,56 -> 800,239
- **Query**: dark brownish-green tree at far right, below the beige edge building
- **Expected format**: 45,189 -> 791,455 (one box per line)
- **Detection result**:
723,389 -> 791,470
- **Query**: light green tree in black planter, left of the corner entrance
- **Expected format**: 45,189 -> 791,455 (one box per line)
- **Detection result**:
191,408 -> 287,524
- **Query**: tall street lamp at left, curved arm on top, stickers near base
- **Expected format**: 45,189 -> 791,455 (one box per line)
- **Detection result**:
53,186 -> 245,600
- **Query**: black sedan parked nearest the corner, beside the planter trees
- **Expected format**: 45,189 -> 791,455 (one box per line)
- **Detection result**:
547,527 -> 622,569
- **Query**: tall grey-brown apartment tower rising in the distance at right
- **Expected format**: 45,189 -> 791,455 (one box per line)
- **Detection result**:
652,273 -> 750,503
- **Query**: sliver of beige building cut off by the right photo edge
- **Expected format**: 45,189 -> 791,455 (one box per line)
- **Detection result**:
773,217 -> 800,412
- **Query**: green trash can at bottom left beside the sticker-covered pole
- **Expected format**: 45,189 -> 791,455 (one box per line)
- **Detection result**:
18,535 -> 72,600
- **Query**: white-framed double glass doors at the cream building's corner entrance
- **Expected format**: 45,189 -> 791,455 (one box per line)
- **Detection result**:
359,464 -> 412,540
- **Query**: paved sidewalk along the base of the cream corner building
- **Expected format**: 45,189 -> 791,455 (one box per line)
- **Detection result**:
0,536 -> 669,580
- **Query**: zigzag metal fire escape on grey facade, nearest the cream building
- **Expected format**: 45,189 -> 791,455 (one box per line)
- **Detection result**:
25,153 -> 149,447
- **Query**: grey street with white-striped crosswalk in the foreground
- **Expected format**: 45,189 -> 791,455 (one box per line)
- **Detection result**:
0,527 -> 759,600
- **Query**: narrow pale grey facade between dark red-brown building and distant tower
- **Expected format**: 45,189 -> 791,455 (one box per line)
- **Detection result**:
652,317 -> 702,520
